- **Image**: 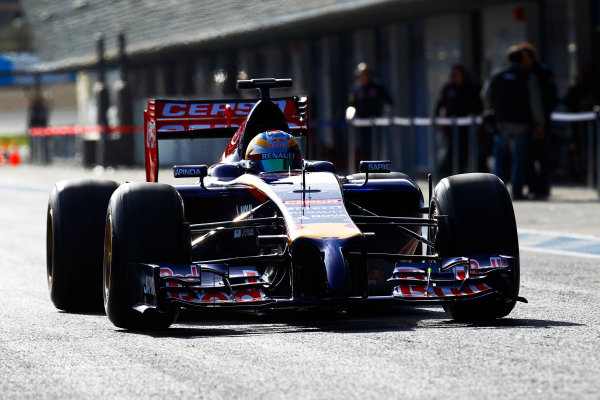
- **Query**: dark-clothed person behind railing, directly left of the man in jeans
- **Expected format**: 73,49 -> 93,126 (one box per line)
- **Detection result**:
435,64 -> 482,177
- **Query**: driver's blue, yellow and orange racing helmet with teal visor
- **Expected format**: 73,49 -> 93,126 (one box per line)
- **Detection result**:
245,130 -> 302,172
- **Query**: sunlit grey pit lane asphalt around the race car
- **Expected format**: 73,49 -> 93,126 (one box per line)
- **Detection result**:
0,166 -> 600,399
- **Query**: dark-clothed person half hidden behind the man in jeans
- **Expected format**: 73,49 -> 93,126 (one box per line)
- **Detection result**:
518,43 -> 558,199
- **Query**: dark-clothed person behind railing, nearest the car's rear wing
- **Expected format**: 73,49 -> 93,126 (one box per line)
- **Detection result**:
348,63 -> 392,158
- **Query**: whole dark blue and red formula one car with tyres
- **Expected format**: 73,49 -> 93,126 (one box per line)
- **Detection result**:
47,79 -> 525,329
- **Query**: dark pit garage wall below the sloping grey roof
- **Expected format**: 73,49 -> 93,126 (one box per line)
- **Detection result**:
70,0 -> 590,171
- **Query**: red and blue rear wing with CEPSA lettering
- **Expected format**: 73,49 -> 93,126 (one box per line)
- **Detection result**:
144,97 -> 308,182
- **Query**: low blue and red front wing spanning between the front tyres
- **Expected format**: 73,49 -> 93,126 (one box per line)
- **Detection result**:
132,255 -> 518,313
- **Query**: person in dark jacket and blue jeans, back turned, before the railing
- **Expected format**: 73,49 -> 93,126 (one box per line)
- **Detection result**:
481,46 -> 544,200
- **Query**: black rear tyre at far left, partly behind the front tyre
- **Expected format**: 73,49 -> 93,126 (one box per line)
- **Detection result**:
46,180 -> 118,311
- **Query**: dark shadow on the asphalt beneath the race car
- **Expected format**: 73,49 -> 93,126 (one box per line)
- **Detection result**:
119,306 -> 584,339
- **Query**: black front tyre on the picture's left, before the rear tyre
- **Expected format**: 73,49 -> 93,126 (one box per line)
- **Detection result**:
103,183 -> 190,330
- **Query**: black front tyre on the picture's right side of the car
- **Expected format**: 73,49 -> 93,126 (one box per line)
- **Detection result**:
430,173 -> 520,320
